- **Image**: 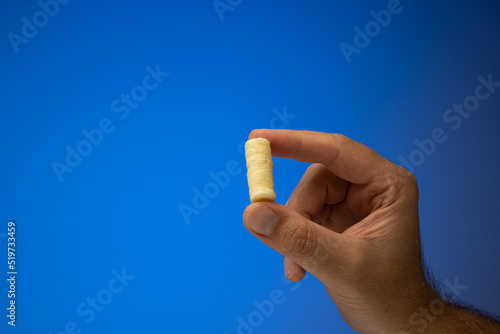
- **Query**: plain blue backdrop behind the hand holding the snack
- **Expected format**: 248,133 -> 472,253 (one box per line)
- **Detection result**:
0,0 -> 500,334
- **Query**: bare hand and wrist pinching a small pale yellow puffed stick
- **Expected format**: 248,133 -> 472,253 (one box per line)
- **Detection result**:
243,129 -> 500,334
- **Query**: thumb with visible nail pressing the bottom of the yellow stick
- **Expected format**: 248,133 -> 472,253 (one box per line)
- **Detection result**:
243,202 -> 346,282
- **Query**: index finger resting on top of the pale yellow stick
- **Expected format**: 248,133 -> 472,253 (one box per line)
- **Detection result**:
248,129 -> 390,184
